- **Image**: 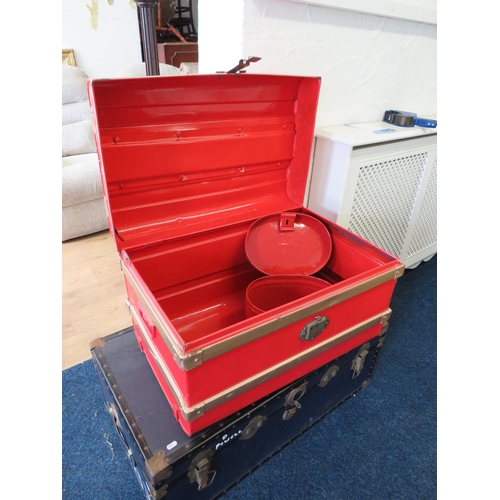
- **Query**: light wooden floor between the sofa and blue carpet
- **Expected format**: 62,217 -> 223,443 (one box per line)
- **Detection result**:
62,231 -> 132,370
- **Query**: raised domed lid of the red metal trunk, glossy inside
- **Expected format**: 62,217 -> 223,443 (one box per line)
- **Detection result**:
89,74 -> 320,250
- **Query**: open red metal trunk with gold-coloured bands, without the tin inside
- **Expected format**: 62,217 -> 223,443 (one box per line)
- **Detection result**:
89,74 -> 404,435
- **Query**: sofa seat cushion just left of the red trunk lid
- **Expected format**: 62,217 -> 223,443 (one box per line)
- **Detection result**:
62,153 -> 103,208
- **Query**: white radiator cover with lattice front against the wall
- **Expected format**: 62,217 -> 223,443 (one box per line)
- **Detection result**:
305,121 -> 437,269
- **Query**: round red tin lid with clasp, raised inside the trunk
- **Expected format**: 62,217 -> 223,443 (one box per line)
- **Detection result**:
245,212 -> 332,276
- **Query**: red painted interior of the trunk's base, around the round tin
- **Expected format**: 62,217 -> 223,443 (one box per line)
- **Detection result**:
123,207 -> 395,348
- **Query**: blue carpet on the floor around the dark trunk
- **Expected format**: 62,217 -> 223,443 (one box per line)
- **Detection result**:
62,256 -> 437,500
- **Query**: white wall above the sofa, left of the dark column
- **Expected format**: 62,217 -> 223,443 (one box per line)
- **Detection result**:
61,0 -> 142,78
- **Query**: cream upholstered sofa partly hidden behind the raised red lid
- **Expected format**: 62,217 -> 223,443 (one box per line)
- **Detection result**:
62,63 -> 181,241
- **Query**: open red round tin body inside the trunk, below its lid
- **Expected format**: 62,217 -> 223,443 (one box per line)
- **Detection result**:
246,276 -> 330,318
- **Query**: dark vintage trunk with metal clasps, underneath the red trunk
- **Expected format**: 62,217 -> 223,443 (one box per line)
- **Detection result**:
92,328 -> 385,500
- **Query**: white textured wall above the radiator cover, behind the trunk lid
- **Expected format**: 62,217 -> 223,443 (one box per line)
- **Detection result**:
198,0 -> 437,126
